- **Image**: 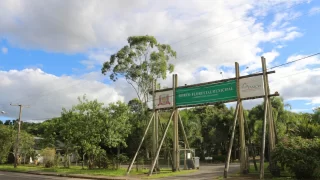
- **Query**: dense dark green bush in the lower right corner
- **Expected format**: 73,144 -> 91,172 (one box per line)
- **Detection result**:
272,137 -> 320,179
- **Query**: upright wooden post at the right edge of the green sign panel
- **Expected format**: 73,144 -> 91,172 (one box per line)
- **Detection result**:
235,62 -> 249,174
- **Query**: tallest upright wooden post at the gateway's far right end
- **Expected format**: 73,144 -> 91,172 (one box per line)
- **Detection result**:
260,57 -> 268,179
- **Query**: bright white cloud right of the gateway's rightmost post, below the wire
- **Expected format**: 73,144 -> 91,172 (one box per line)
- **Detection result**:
269,55 -> 320,104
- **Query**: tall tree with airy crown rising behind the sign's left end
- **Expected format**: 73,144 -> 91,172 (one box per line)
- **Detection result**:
101,35 -> 176,107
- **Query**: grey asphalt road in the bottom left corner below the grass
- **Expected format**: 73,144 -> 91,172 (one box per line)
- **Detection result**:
0,171 -> 91,180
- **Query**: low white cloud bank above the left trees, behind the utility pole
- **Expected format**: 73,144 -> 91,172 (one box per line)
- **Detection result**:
0,69 -> 124,120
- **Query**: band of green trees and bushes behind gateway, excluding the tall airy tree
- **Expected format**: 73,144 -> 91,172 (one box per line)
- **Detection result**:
0,96 -> 320,178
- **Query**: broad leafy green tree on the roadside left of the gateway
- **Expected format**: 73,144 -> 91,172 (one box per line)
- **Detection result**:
43,96 -> 131,168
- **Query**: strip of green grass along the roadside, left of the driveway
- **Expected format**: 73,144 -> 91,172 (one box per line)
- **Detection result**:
0,165 -> 197,179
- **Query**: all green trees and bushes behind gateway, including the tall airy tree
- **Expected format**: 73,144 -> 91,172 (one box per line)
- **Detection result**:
0,36 -> 320,178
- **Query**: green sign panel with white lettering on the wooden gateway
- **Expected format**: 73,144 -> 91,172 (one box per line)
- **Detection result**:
175,80 -> 237,106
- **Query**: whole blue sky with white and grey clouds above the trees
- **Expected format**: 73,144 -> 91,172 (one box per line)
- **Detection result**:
0,0 -> 320,122
